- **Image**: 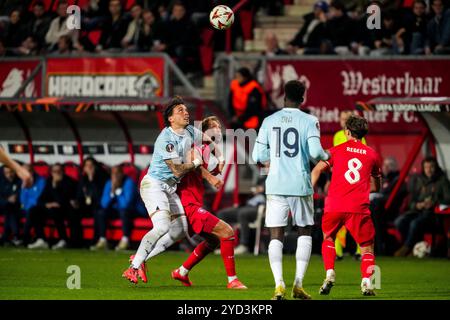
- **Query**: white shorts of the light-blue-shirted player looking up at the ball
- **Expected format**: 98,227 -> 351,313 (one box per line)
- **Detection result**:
140,176 -> 184,217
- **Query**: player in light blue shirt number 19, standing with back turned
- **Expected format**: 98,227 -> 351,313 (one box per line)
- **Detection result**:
252,80 -> 329,300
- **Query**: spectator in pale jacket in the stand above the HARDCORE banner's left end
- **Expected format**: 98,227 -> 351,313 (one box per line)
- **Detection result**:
45,1 -> 83,52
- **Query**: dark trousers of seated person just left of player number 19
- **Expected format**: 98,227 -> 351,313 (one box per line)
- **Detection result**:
217,206 -> 258,247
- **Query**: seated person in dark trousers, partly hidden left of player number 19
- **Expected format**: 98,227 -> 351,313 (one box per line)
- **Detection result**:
217,180 -> 266,254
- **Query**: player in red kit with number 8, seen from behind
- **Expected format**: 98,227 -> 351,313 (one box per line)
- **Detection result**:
311,115 -> 381,296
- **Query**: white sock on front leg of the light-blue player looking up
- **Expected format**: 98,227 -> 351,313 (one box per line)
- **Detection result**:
131,211 -> 170,269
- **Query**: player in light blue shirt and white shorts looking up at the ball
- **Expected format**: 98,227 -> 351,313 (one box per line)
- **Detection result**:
123,97 -> 203,283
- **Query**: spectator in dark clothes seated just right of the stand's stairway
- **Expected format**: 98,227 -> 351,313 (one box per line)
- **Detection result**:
287,1 -> 328,54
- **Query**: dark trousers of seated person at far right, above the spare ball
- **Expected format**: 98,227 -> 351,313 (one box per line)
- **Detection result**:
395,211 -> 436,248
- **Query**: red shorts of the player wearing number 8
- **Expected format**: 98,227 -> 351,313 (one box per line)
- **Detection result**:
322,212 -> 375,247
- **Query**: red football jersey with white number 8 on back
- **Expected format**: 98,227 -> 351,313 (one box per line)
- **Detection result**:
325,140 -> 381,214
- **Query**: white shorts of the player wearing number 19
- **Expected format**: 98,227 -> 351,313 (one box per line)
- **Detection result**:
266,194 -> 314,228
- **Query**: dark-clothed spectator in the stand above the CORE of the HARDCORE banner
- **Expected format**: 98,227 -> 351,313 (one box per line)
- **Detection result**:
96,0 -> 128,52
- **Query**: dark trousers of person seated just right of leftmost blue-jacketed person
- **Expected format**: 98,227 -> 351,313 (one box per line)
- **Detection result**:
30,206 -> 70,241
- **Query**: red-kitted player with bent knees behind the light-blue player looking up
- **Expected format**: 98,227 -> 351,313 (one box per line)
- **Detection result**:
141,117 -> 247,289
